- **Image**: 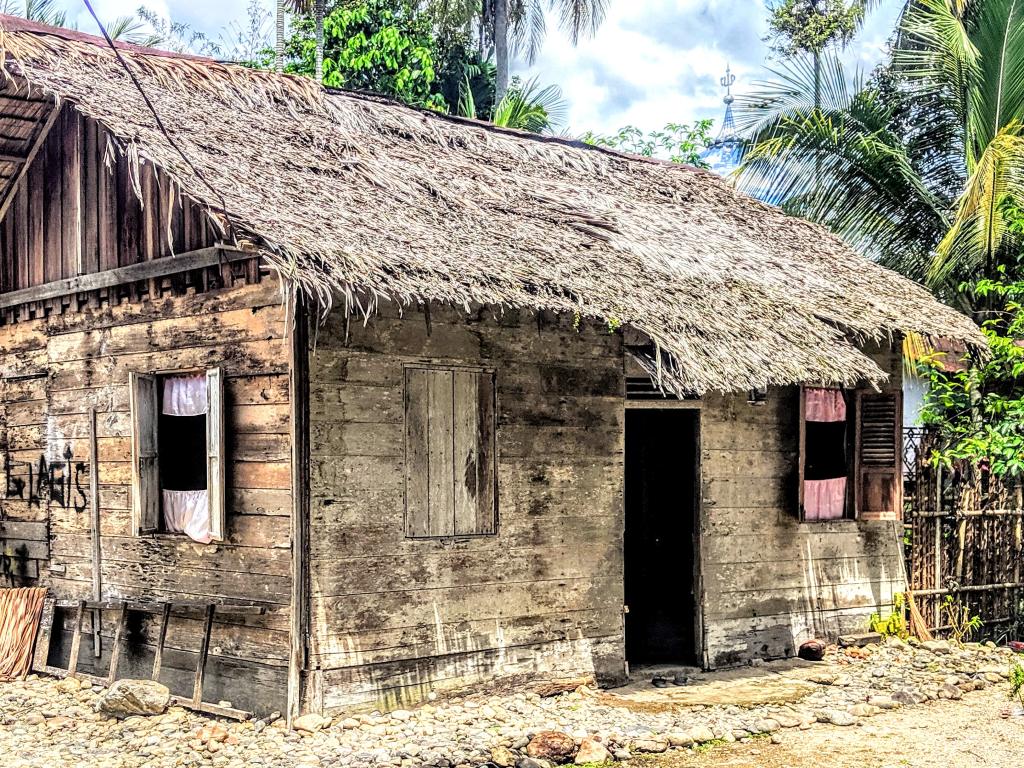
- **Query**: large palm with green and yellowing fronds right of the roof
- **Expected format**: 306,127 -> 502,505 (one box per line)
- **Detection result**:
737,0 -> 1024,299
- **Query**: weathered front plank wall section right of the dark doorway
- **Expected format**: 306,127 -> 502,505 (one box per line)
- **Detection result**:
700,344 -> 905,667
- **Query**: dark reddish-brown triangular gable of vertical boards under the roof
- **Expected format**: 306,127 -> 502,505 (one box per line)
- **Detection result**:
0,104 -> 216,291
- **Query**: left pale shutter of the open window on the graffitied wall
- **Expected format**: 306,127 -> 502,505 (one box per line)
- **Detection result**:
128,373 -> 160,535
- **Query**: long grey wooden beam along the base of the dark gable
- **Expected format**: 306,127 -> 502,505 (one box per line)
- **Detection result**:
0,247 -> 258,309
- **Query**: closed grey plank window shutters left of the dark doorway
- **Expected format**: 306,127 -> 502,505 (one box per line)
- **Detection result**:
406,367 -> 497,538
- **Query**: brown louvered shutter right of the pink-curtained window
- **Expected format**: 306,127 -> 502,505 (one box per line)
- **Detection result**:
855,391 -> 903,520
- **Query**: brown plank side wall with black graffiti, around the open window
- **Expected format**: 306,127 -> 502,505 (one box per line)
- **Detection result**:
0,280 -> 291,710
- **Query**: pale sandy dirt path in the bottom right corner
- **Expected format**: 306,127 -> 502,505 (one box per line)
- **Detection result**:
645,685 -> 1024,768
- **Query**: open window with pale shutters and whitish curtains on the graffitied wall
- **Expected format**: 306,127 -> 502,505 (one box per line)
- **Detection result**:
128,369 -> 226,542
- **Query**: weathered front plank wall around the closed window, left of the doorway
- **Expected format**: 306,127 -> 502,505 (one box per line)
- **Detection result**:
307,306 -> 625,710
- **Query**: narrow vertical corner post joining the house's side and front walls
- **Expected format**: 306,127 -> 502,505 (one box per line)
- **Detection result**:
286,290 -> 309,728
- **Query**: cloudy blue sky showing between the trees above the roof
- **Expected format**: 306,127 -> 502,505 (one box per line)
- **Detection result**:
51,0 -> 902,135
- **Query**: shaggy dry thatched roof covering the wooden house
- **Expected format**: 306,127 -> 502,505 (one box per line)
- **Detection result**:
0,17 -> 982,392
